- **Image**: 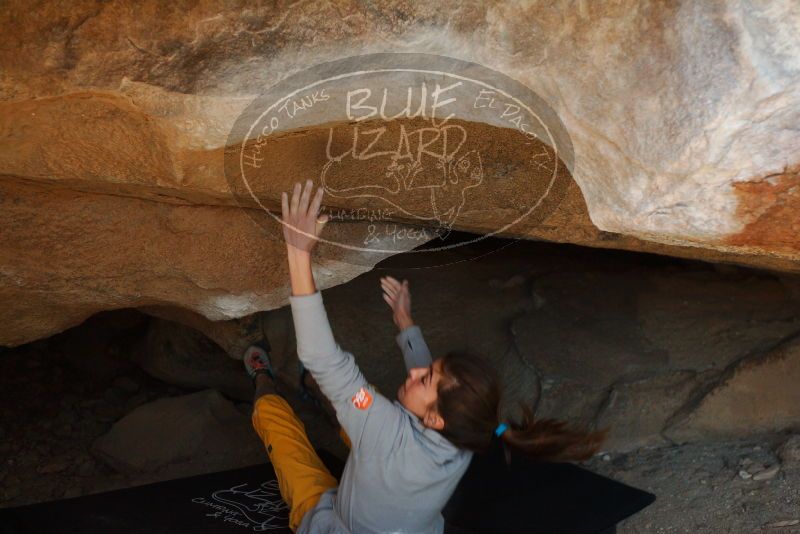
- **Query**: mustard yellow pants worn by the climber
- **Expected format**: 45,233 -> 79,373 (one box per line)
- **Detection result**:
252,394 -> 350,532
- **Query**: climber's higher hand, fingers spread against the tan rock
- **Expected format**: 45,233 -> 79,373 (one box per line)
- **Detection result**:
281,179 -> 330,254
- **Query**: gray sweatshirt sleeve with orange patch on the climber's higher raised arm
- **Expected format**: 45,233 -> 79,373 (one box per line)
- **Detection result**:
289,290 -> 403,454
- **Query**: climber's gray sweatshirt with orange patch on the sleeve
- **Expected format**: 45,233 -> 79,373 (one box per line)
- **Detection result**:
289,290 -> 472,534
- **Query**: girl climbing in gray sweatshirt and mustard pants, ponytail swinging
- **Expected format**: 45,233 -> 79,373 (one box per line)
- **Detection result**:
245,180 -> 606,534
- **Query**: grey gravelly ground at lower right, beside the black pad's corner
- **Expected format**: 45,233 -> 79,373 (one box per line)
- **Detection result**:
584,435 -> 800,534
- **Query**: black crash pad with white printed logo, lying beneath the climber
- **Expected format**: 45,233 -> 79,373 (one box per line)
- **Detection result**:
0,448 -> 655,534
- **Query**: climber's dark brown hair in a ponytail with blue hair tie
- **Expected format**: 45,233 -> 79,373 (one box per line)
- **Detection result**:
437,350 -> 609,462
